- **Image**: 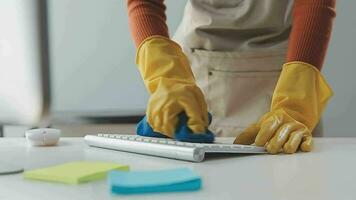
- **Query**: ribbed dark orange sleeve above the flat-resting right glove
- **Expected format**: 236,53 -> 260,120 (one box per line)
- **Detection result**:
287,0 -> 335,70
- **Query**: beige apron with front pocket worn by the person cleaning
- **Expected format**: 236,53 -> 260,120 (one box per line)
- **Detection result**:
173,0 -> 322,136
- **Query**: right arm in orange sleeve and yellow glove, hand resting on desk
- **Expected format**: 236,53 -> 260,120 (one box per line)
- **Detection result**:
235,0 -> 335,154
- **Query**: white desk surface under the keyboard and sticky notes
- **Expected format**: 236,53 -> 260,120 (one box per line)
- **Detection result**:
0,138 -> 356,200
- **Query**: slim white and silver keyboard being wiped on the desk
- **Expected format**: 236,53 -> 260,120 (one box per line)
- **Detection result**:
84,134 -> 266,162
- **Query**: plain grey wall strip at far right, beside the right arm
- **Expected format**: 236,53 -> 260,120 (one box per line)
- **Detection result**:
323,0 -> 356,136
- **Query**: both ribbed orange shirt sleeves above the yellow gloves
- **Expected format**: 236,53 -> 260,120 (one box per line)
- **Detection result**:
127,0 -> 335,69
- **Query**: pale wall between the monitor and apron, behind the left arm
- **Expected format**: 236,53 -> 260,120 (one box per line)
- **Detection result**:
49,0 -> 185,115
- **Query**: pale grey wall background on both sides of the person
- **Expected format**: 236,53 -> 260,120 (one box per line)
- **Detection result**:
49,0 -> 356,136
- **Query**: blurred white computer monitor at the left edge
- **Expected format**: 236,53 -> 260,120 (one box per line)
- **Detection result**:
0,0 -> 50,130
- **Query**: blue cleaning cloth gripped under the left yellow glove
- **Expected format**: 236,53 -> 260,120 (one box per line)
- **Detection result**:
136,113 -> 214,143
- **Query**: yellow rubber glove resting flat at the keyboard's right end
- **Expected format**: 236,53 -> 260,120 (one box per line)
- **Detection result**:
234,62 -> 333,154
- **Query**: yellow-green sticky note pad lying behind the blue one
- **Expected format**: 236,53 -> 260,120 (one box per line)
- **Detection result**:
24,161 -> 129,184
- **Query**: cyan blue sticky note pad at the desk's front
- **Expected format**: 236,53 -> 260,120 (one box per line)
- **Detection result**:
108,168 -> 201,194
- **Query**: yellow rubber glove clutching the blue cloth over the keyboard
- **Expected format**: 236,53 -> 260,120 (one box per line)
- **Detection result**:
136,36 -> 208,137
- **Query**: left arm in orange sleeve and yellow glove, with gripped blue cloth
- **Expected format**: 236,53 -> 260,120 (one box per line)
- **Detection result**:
127,0 -> 214,142
